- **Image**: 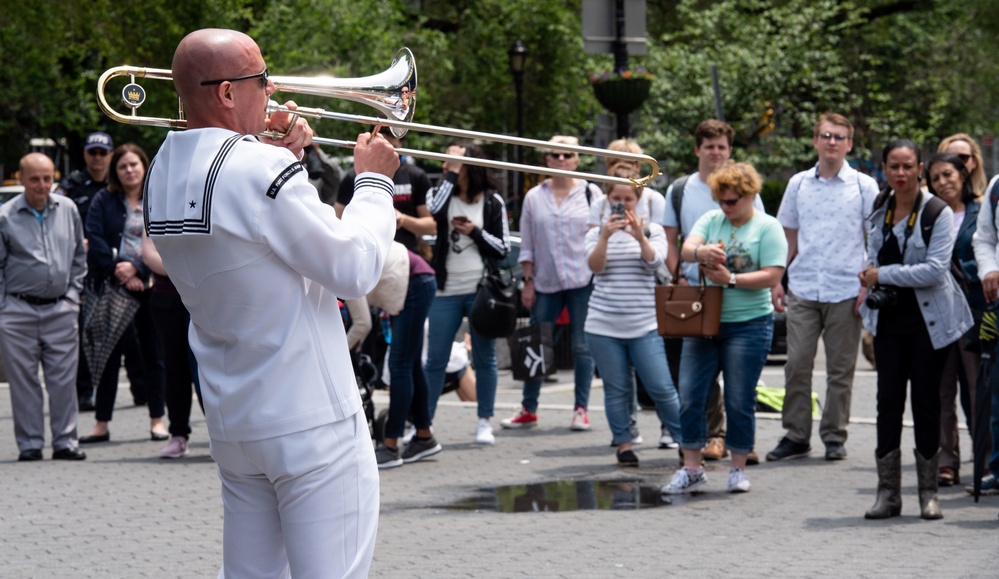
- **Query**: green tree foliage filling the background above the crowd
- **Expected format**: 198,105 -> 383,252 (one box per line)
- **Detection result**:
0,0 -> 999,185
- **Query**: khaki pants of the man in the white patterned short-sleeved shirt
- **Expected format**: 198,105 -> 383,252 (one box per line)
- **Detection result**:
783,293 -> 861,444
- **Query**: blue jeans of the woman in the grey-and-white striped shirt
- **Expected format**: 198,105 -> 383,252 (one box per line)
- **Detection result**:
586,330 -> 680,444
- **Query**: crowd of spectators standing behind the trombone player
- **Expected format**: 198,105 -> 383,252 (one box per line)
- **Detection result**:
0,113 -> 999,519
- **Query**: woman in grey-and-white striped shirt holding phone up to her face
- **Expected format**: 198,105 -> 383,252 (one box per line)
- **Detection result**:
585,166 -> 680,467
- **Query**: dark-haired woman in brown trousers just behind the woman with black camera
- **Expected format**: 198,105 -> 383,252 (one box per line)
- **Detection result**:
926,151 -> 986,486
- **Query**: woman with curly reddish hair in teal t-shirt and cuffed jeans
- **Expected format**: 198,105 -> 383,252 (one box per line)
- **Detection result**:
663,162 -> 787,494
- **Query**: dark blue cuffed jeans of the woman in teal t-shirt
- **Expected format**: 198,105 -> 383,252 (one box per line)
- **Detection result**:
680,314 -> 774,454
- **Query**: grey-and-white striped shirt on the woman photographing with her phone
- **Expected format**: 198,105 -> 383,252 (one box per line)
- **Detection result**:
584,223 -> 666,340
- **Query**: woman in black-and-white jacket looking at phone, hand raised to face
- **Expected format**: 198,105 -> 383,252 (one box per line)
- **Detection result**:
426,142 -> 510,444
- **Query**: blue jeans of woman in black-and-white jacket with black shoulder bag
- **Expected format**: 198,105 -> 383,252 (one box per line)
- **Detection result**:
427,293 -> 496,420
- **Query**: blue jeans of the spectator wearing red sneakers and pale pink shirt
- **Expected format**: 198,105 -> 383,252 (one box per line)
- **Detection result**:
521,284 -> 593,412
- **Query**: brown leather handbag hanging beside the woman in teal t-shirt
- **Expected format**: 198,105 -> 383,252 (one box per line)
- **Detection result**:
656,264 -> 722,338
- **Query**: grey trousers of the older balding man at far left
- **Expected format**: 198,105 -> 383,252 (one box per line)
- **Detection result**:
0,295 -> 80,452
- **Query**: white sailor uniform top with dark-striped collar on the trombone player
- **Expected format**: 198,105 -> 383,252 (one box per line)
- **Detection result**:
144,128 -> 395,441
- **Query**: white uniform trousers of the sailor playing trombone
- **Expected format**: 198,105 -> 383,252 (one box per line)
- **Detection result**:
211,414 -> 379,579
